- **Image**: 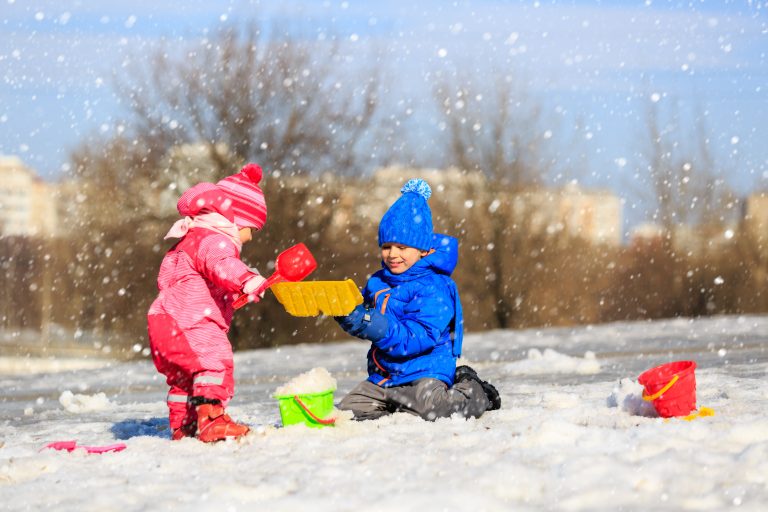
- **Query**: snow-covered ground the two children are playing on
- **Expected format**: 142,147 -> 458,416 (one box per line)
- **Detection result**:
0,316 -> 768,512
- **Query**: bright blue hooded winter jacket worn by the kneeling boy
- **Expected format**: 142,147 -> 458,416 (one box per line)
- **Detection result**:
363,234 -> 464,387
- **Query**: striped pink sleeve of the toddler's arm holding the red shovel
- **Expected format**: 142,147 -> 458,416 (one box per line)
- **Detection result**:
198,235 -> 255,292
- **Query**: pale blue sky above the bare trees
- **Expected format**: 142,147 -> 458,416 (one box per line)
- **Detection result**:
0,0 -> 768,226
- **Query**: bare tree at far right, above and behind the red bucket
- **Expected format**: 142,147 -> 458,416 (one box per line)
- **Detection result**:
619,98 -> 738,318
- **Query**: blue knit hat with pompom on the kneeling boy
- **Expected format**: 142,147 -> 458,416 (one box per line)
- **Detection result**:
379,179 -> 432,251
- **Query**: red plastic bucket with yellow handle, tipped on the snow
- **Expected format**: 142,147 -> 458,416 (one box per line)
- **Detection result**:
637,361 -> 696,418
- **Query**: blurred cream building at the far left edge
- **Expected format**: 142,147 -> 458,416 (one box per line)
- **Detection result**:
0,156 -> 58,236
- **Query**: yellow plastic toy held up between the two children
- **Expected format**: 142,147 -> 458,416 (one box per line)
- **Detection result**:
271,279 -> 363,316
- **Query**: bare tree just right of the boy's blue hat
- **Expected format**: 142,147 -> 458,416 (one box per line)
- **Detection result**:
434,71 -> 553,328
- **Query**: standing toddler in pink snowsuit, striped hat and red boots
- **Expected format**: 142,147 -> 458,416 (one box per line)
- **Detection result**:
147,164 -> 267,442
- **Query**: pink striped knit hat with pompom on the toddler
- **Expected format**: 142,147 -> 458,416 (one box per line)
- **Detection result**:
216,164 -> 267,229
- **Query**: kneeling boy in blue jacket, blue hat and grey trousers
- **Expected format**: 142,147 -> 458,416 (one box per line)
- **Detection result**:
336,180 -> 501,421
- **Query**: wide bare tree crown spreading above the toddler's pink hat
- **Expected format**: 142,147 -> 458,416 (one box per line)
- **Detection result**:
117,22 -> 379,175
